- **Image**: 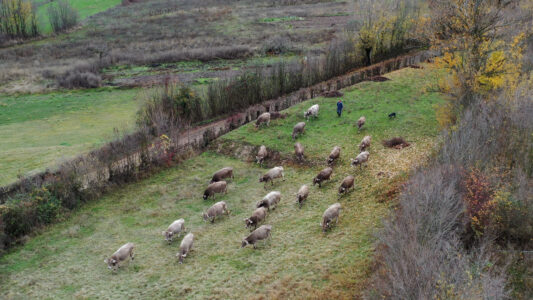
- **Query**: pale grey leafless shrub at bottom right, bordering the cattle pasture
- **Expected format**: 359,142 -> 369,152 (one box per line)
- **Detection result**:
369,165 -> 506,299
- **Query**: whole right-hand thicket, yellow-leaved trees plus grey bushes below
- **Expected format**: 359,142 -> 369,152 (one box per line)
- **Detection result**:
368,0 -> 533,299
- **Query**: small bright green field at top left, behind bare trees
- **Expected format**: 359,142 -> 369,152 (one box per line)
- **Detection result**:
35,0 -> 121,33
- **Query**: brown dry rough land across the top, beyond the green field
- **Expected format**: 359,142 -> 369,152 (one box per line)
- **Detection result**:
0,0 -> 353,91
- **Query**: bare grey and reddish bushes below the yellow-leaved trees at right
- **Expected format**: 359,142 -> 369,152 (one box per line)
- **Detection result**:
369,93 -> 533,299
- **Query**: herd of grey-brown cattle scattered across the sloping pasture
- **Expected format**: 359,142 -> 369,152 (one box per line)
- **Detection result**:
105,104 -> 378,270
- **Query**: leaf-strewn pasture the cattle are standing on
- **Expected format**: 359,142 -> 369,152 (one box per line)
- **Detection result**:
0,68 -> 442,299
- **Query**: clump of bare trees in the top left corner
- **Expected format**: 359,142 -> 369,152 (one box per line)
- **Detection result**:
0,0 -> 39,41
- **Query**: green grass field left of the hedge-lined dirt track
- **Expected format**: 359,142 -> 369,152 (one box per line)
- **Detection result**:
0,89 -> 140,185
